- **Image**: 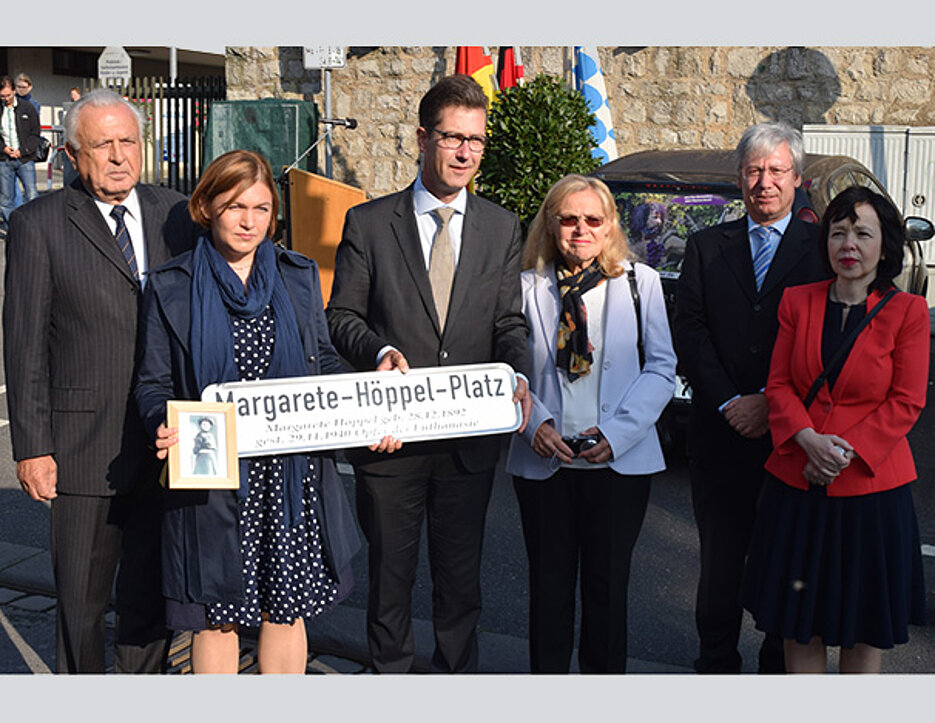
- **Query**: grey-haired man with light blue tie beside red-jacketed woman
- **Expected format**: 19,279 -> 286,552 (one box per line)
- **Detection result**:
675,123 -> 828,673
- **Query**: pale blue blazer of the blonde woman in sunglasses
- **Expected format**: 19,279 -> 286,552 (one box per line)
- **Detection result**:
506,262 -> 676,480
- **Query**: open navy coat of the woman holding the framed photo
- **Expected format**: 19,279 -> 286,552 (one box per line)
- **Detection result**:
134,248 -> 360,603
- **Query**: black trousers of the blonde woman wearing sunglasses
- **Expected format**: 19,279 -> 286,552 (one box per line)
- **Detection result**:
513,469 -> 650,673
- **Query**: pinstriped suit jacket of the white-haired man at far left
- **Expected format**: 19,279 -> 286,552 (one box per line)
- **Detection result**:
3,180 -> 195,495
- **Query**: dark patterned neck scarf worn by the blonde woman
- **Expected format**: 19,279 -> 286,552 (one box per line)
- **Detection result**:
555,263 -> 607,382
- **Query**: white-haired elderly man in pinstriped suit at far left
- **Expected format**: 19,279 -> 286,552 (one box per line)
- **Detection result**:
3,90 -> 195,673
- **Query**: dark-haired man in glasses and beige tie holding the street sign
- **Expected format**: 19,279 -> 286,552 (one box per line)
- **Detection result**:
328,75 -> 530,673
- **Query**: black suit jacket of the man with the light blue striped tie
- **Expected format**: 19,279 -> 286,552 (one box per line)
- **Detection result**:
675,216 -> 830,464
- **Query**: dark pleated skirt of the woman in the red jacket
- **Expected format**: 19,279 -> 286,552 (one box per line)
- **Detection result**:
743,474 -> 925,648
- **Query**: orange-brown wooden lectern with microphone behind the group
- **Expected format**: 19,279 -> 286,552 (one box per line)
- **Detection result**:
289,168 -> 367,306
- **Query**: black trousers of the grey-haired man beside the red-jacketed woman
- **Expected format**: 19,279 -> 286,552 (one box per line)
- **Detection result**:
689,460 -> 785,674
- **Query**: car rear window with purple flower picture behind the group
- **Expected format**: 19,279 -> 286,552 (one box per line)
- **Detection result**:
608,191 -> 744,278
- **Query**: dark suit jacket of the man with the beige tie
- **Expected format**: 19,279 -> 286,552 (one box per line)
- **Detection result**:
327,186 -> 529,471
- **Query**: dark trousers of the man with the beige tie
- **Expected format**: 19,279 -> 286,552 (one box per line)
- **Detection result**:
355,453 -> 494,673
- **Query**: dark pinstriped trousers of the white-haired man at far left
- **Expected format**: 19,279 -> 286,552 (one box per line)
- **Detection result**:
51,488 -> 171,673
